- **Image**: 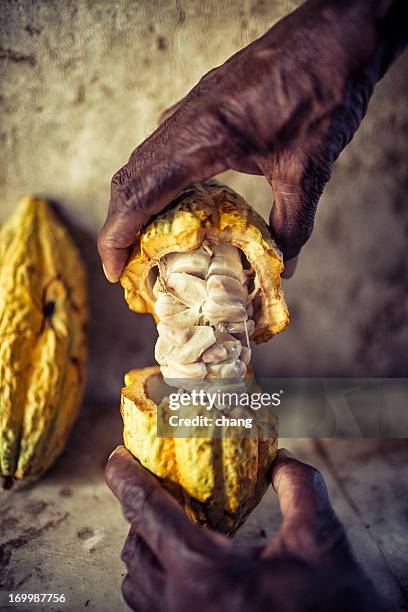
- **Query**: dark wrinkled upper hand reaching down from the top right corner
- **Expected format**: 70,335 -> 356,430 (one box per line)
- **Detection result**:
98,0 -> 407,282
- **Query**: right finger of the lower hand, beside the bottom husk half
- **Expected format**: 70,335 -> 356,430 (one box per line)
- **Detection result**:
265,449 -> 350,561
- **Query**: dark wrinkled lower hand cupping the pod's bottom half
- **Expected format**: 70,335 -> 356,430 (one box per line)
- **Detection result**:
106,446 -> 383,612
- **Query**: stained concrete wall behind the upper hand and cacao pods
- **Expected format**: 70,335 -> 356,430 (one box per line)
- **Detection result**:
0,0 -> 408,403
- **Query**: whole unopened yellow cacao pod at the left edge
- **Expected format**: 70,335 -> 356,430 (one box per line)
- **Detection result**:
0,197 -> 87,485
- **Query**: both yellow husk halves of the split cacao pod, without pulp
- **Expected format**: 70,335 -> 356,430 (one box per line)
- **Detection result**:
121,181 -> 289,533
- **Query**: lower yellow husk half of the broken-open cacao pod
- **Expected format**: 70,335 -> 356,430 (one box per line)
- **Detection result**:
121,367 -> 278,534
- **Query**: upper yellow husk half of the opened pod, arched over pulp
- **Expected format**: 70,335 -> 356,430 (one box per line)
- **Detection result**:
120,181 -> 289,343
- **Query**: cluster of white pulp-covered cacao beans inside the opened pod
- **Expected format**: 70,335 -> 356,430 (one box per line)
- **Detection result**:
153,244 -> 256,387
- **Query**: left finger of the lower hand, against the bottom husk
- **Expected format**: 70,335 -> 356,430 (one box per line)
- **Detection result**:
105,446 -> 224,568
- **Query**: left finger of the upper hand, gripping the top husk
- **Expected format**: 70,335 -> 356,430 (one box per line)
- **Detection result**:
98,109 -> 226,282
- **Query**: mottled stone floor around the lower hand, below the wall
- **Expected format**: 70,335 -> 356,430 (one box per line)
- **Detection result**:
0,407 -> 408,612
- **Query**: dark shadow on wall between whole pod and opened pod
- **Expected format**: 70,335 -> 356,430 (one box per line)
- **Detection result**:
52,202 -> 156,408
